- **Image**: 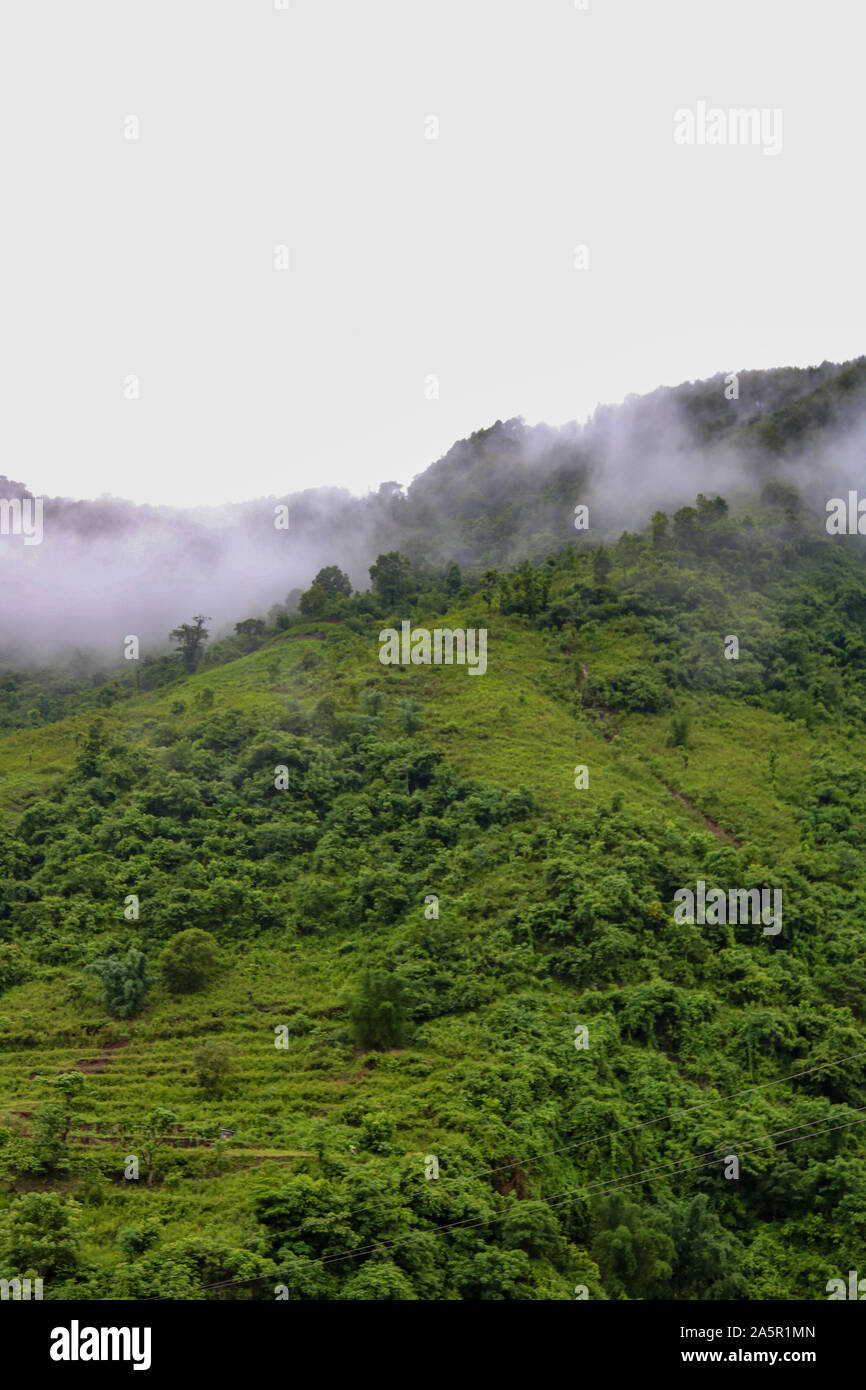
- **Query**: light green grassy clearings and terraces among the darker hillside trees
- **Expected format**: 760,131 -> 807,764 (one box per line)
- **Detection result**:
0,616 -> 865,1289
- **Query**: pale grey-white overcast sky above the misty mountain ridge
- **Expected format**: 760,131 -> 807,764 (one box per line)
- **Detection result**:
0,0 -> 866,505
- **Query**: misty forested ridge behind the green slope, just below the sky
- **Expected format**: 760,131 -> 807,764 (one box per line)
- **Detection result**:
0,359 -> 866,667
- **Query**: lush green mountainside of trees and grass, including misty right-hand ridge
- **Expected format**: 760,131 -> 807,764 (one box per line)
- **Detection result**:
0,359 -> 866,1300
